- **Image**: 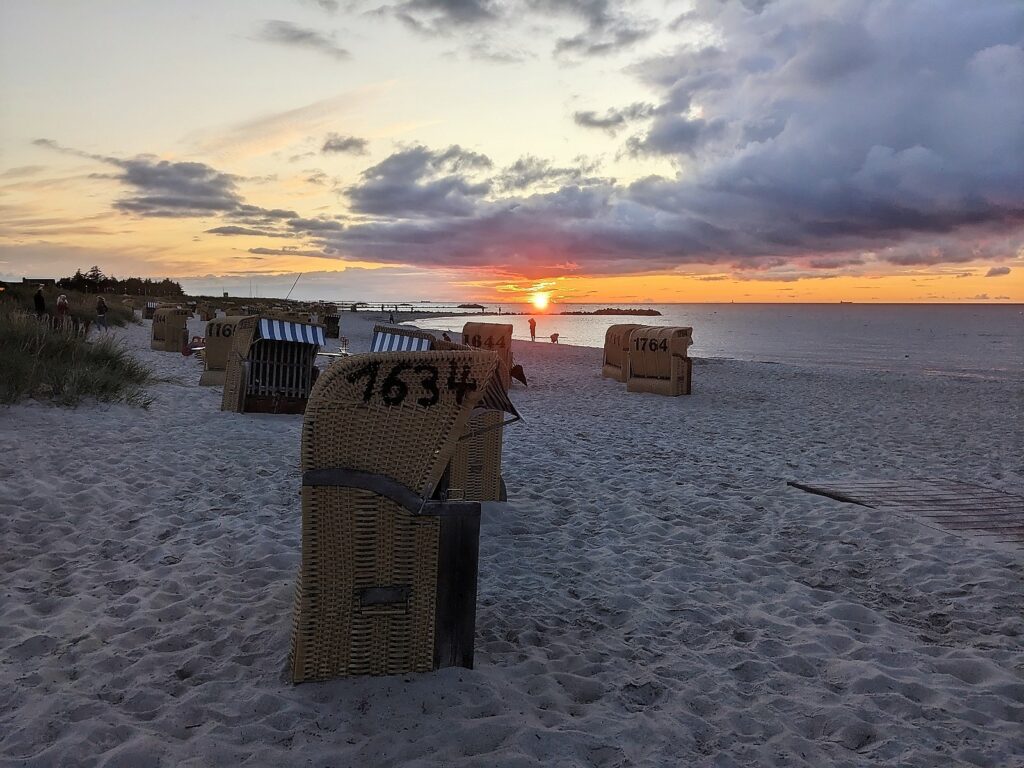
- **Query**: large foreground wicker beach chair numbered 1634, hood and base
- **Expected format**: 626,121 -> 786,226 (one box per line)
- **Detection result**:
290,350 -> 498,682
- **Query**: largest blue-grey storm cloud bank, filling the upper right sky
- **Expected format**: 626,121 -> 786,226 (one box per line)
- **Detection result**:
321,0 -> 1024,274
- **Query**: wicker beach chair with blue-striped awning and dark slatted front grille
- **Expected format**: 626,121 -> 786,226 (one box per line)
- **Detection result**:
220,315 -> 324,414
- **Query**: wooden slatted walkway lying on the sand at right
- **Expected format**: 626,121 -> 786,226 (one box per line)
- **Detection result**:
787,478 -> 1024,549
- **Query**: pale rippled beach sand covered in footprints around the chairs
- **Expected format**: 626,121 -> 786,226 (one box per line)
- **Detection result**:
0,317 -> 1024,767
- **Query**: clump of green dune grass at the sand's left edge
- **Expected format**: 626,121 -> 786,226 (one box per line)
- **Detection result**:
0,300 -> 153,408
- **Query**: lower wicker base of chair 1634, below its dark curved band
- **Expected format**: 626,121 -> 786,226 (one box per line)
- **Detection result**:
291,470 -> 480,683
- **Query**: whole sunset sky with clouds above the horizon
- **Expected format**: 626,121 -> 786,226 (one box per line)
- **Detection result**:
0,0 -> 1024,303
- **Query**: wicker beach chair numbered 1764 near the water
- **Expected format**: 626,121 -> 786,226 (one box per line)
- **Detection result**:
626,326 -> 693,396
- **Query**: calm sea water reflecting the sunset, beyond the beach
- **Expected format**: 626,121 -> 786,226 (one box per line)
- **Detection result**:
412,304 -> 1024,379
